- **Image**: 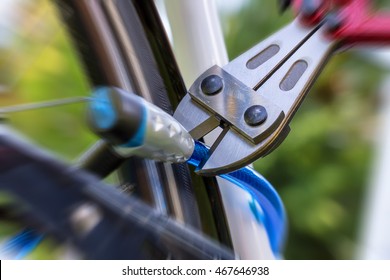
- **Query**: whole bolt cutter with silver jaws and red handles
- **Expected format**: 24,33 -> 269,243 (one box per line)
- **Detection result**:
174,0 -> 390,175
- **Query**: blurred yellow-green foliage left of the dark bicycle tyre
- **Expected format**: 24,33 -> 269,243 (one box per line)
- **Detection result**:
0,0 -> 94,160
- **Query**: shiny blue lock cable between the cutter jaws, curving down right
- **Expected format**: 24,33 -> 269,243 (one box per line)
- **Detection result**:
188,141 -> 286,256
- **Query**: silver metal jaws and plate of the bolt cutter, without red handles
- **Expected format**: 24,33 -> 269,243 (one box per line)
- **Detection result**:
175,21 -> 336,176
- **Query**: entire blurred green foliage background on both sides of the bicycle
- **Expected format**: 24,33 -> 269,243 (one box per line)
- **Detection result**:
0,0 -> 383,259
